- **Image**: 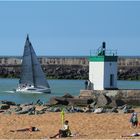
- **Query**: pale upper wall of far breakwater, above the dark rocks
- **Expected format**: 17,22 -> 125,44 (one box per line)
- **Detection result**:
0,56 -> 140,67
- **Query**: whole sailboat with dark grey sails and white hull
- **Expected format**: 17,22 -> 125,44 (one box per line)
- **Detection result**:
16,35 -> 51,93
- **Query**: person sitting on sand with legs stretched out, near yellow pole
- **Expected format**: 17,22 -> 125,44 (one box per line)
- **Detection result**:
50,120 -> 71,138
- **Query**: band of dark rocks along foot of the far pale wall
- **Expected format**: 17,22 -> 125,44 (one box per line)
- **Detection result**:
0,65 -> 140,80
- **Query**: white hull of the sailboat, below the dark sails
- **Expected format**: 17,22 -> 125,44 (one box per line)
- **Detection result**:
16,87 -> 51,93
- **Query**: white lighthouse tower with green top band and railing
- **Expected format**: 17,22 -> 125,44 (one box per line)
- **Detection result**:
89,42 -> 117,90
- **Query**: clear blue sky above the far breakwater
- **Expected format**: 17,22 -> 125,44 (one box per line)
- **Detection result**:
0,1 -> 140,56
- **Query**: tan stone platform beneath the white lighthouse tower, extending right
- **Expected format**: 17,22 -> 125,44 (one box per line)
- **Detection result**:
79,89 -> 140,106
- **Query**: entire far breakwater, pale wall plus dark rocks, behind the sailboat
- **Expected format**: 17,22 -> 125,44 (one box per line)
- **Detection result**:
0,56 -> 140,80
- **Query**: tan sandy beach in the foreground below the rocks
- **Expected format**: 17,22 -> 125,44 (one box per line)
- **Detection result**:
0,109 -> 140,139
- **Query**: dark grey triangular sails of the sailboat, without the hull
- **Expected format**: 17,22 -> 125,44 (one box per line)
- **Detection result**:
20,35 -> 50,88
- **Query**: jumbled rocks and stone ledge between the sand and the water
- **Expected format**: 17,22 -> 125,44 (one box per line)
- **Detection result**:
0,90 -> 140,115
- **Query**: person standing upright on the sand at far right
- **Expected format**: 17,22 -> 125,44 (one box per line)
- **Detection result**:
130,112 -> 138,128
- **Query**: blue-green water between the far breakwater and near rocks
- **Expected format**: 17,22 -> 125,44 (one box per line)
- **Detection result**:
0,78 -> 140,104
